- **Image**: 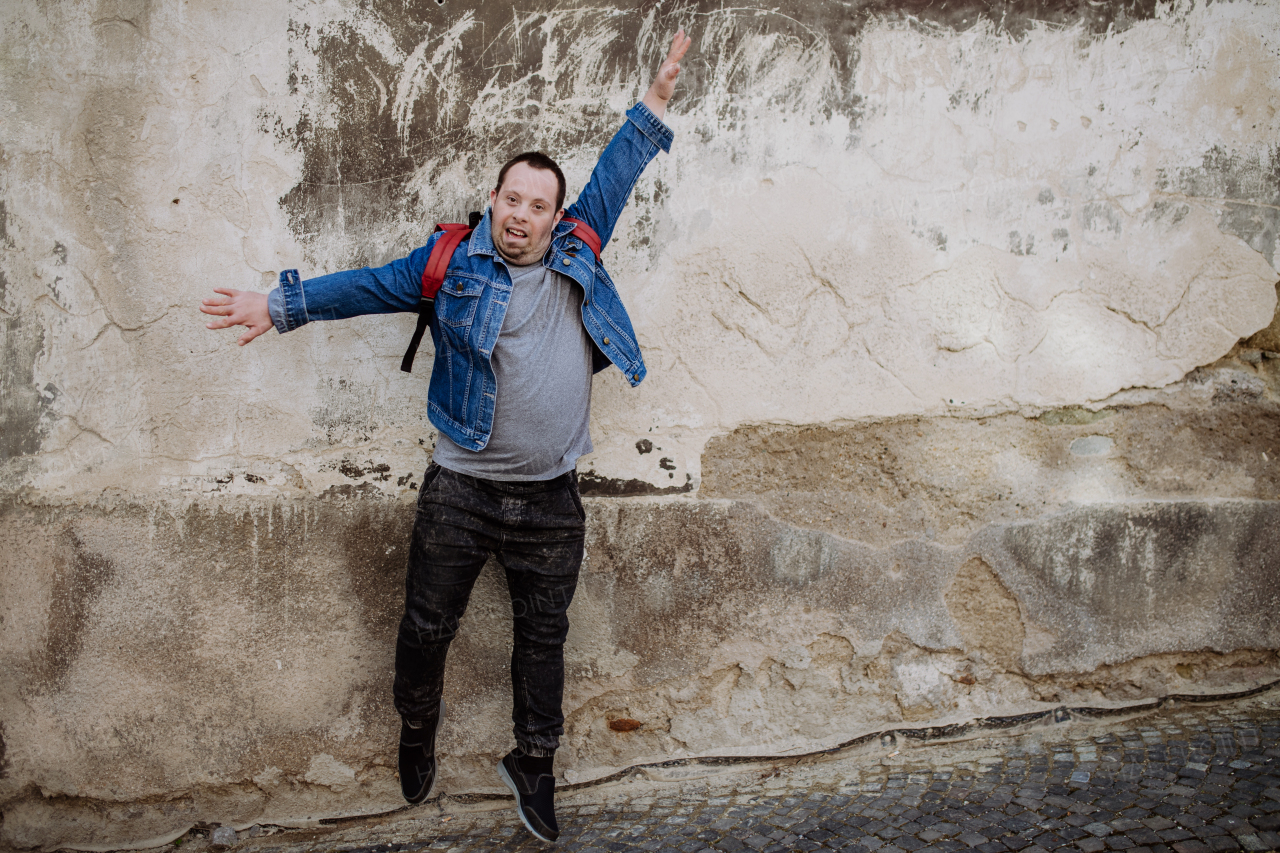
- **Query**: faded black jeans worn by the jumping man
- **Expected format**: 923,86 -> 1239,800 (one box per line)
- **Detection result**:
394,464 -> 586,756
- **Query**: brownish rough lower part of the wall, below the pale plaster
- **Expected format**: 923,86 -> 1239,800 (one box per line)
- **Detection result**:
0,350 -> 1280,849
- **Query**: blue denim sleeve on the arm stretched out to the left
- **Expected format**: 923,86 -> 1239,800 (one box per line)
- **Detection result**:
268,234 -> 436,333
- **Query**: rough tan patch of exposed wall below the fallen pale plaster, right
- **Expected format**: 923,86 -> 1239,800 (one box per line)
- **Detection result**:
699,359 -> 1280,546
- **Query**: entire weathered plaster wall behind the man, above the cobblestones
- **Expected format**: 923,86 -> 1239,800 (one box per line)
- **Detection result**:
0,0 -> 1280,848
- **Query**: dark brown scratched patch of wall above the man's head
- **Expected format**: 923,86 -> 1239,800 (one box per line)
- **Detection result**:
272,1 -> 847,264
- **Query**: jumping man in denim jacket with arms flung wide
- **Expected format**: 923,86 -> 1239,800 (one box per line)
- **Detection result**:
200,29 -> 690,841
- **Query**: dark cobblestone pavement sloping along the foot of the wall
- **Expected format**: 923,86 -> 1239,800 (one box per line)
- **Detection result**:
209,690 -> 1280,853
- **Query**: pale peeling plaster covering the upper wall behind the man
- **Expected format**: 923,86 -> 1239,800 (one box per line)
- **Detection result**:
0,1 -> 1280,494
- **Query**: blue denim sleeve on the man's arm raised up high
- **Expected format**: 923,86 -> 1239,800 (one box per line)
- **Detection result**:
563,104 -> 675,248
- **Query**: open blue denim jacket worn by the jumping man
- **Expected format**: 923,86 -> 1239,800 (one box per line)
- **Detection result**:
269,104 -> 672,451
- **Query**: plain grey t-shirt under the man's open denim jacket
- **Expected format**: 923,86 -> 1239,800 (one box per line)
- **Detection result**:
434,261 -> 591,480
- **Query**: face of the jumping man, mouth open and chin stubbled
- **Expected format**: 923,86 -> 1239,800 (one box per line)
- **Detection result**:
489,163 -> 564,266
